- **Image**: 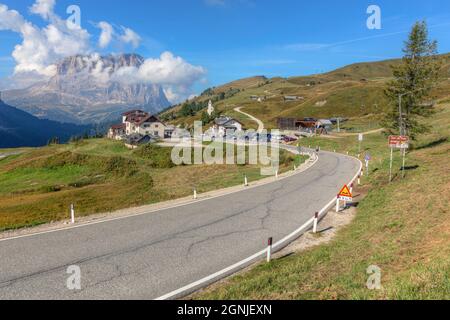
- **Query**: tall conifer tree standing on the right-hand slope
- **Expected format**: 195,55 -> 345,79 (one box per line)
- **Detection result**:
384,21 -> 441,139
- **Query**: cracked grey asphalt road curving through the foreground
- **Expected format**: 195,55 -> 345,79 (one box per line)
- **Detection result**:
0,152 -> 360,299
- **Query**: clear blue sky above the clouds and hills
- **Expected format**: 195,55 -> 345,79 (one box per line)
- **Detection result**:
0,0 -> 450,96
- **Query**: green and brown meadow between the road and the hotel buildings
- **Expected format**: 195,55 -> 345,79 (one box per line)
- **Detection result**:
0,139 -> 302,231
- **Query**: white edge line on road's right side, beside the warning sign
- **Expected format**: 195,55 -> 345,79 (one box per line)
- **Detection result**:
155,156 -> 363,300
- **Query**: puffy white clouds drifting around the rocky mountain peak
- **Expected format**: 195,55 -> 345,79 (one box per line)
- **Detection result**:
0,0 -> 206,102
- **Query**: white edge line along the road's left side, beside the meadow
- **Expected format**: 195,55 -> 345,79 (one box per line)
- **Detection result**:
0,148 -> 319,242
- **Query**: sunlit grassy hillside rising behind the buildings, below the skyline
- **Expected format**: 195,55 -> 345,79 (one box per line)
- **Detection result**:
162,54 -> 450,128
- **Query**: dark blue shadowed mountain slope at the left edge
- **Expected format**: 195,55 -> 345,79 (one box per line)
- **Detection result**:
0,100 -> 91,148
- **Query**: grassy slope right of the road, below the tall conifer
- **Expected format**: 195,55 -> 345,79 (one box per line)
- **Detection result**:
197,104 -> 450,299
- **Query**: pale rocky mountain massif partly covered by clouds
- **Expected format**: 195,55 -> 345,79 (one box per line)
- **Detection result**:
2,54 -> 170,124
